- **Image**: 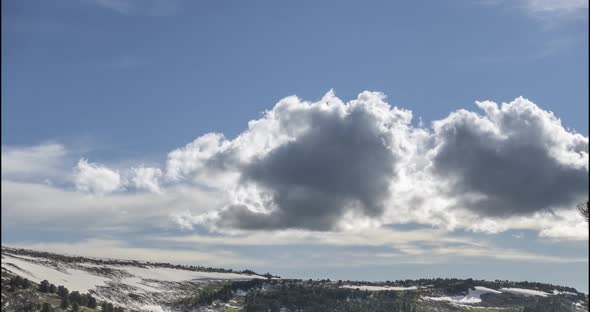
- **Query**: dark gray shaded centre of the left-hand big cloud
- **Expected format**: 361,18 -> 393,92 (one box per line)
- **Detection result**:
220,110 -> 396,230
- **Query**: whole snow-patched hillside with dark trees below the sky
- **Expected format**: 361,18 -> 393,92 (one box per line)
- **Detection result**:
2,247 -> 588,312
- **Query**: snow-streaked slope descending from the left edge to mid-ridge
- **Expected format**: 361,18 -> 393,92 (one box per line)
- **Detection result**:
2,248 -> 266,311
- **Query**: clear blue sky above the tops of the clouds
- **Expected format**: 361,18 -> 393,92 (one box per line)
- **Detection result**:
2,1 -> 588,157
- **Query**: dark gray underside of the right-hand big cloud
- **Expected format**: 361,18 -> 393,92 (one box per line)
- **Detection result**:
433,112 -> 588,217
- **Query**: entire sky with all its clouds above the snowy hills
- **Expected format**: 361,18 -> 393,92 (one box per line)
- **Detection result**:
1,0 -> 589,292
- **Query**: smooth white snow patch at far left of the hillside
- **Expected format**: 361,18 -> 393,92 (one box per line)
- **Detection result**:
2,255 -> 109,293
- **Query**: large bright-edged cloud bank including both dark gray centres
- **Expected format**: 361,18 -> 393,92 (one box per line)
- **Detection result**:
3,92 -> 588,239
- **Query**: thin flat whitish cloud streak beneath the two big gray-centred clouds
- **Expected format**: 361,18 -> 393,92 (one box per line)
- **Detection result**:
154,227 -> 587,266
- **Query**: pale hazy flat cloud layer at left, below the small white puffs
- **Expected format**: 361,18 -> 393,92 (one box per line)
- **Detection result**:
1,180 -> 227,235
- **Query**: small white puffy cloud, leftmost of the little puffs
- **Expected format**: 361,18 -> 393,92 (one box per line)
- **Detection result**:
74,159 -> 123,195
